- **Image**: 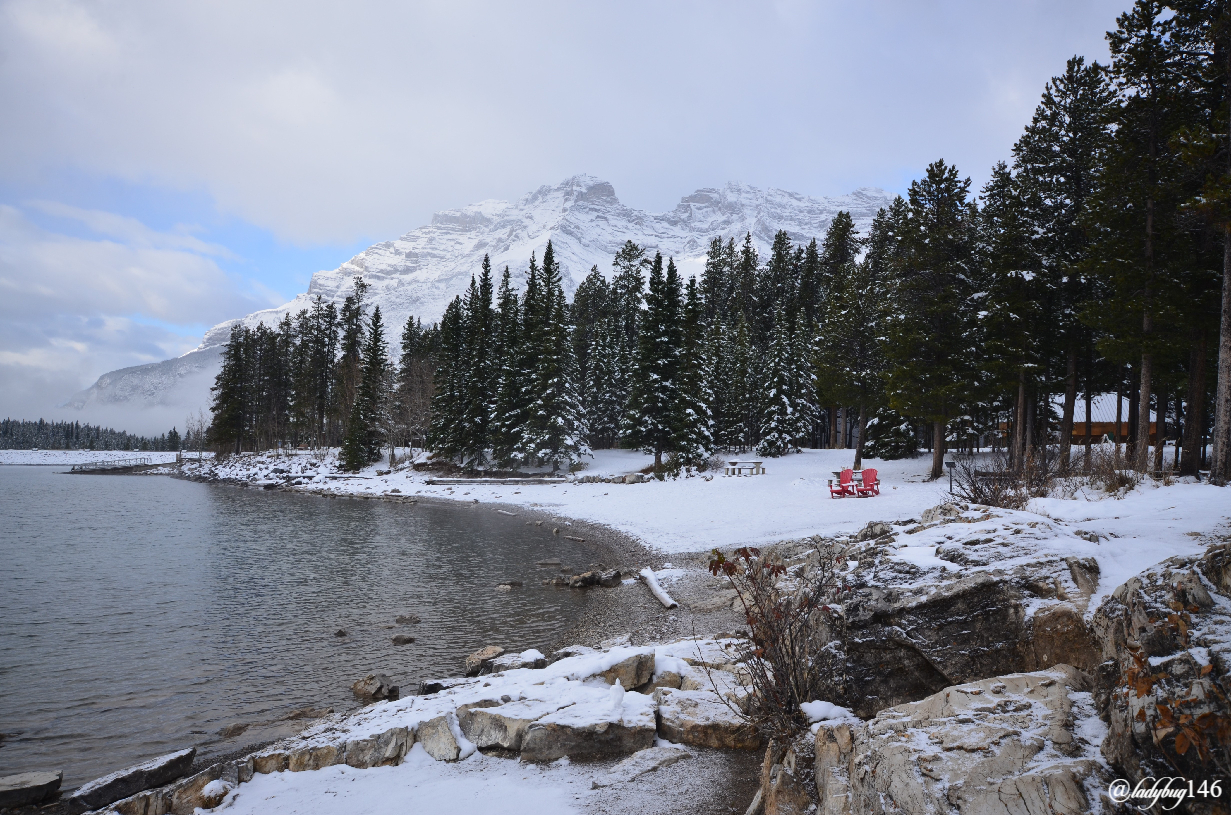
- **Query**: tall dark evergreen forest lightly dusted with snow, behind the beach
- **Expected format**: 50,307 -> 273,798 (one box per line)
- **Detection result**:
211,0 -> 1231,480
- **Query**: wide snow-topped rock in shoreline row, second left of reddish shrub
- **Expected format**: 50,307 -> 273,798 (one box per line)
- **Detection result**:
522,688 -> 655,762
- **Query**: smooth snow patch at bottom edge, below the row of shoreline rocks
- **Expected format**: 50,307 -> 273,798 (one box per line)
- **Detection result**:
216,744 -> 591,815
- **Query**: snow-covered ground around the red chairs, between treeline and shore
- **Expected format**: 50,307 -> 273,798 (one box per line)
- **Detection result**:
186,449 -> 1231,612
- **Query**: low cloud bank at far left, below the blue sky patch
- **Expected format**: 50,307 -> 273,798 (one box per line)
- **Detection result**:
0,202 -> 281,417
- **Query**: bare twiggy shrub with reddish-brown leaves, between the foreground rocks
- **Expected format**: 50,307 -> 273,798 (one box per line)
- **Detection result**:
709,545 -> 849,744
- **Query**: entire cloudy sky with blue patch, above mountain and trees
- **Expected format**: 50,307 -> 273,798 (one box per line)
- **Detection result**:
0,0 -> 1128,428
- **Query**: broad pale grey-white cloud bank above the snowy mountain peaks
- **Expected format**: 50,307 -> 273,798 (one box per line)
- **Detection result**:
0,0 -> 1125,243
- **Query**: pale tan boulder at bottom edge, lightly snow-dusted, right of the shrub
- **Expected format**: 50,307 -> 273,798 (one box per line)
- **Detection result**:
814,665 -> 1110,815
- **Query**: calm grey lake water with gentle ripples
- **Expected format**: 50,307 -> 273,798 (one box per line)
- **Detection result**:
0,467 -> 597,788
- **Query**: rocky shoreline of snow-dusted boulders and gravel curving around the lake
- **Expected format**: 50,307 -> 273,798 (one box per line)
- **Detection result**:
4,460 -> 1231,815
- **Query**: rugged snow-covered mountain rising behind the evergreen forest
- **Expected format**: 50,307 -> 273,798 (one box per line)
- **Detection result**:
68,175 -> 892,423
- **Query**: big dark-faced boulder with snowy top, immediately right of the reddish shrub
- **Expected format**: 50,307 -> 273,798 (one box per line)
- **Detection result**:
817,514 -> 1099,718
